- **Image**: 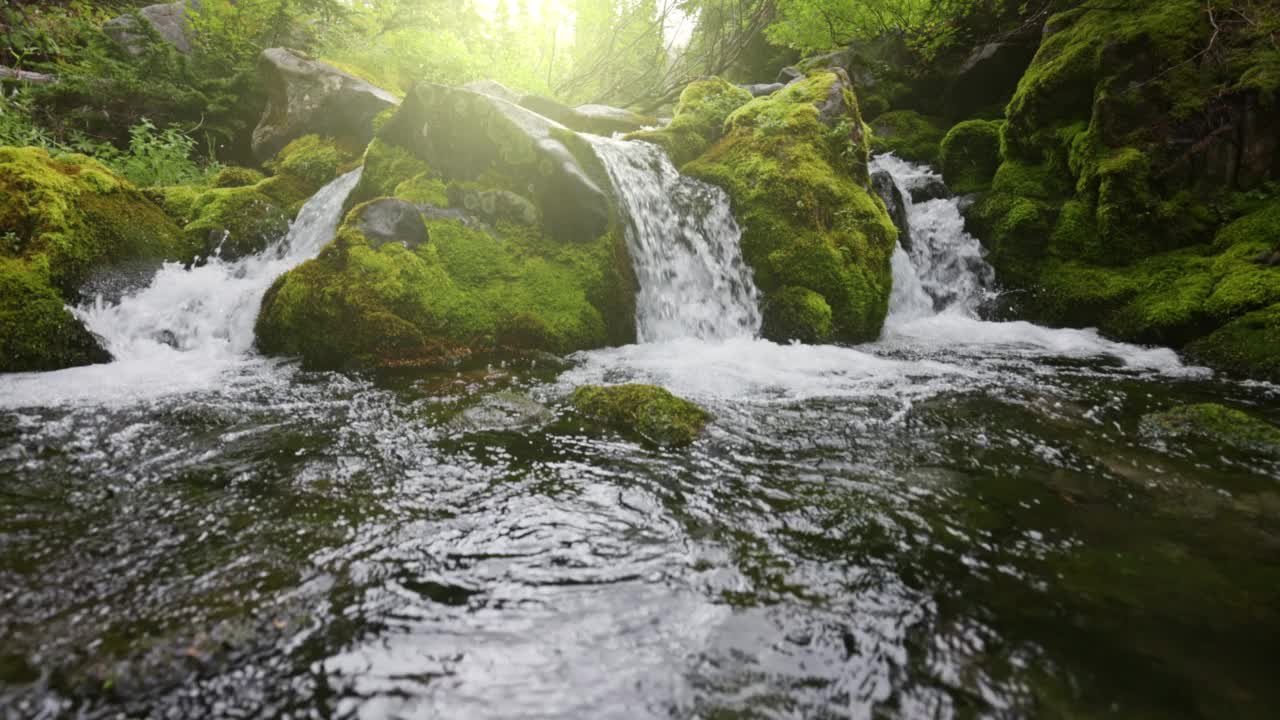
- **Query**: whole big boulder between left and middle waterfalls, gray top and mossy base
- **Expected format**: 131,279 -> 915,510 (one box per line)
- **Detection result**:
256,83 -> 636,368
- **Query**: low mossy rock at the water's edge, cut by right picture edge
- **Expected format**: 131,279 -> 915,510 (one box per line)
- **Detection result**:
1187,302 -> 1280,383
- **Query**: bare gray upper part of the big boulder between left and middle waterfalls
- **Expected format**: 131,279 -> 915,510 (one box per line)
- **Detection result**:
379,82 -> 611,241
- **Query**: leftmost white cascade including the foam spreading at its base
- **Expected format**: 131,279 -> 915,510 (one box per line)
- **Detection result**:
0,165 -> 360,407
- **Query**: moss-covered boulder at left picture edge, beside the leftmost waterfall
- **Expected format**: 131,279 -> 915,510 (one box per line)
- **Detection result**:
0,147 -> 186,372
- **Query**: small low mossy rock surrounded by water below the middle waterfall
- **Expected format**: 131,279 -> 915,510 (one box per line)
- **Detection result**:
570,384 -> 712,447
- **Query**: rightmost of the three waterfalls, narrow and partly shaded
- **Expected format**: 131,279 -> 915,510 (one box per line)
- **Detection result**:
872,155 -> 996,325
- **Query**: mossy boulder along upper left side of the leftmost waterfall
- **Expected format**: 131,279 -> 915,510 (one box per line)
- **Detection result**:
177,135 -> 355,259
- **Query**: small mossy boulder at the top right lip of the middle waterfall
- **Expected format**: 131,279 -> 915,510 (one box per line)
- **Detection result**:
627,77 -> 751,168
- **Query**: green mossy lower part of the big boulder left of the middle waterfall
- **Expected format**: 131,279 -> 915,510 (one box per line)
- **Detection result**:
256,196 -> 635,368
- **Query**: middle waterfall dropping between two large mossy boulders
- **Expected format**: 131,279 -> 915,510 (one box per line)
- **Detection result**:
589,137 -> 760,342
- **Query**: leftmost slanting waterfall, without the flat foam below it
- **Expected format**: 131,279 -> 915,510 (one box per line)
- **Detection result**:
74,169 -> 360,361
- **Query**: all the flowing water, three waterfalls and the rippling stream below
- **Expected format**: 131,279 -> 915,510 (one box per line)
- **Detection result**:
0,145 -> 1280,719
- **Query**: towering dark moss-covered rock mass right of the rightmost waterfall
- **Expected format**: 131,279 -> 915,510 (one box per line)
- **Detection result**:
966,0 -> 1280,372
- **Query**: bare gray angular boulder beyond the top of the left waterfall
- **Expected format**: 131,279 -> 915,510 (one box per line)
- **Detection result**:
253,47 -> 399,161
